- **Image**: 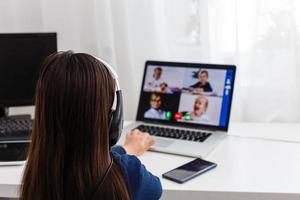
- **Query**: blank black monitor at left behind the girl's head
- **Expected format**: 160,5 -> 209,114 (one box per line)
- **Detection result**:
0,33 -> 57,107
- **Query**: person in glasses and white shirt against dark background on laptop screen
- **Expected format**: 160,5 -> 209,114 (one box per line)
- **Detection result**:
144,93 -> 165,119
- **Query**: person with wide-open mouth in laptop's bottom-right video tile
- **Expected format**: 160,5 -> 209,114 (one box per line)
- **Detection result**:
190,96 -> 210,122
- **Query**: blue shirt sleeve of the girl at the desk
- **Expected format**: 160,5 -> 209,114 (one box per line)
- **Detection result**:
111,146 -> 162,200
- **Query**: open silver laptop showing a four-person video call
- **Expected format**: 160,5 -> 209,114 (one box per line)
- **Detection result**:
123,61 -> 236,157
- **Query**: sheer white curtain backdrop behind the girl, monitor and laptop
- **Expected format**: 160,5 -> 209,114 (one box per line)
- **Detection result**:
0,0 -> 300,122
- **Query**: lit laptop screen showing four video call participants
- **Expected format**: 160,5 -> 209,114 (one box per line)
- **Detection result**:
137,61 -> 235,130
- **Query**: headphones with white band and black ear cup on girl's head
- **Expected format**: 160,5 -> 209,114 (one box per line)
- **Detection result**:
95,57 -> 123,147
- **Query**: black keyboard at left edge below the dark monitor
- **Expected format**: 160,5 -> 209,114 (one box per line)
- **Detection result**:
0,115 -> 32,141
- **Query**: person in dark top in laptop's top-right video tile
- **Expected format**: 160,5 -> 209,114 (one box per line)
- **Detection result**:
190,70 -> 213,93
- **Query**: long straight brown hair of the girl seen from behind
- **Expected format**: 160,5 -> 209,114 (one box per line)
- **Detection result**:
20,51 -> 129,200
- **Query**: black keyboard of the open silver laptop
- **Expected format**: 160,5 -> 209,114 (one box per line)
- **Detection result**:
136,125 -> 211,142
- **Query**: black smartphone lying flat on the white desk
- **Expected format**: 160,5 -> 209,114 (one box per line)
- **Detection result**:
162,158 -> 217,183
